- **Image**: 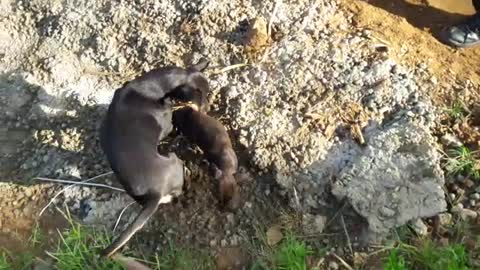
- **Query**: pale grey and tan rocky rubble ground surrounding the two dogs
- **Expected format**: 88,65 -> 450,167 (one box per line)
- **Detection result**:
0,0 -> 480,268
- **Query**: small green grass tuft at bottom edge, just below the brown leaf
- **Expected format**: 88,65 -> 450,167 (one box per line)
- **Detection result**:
275,233 -> 313,270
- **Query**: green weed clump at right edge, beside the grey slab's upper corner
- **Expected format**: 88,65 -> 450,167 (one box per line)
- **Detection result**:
445,146 -> 480,180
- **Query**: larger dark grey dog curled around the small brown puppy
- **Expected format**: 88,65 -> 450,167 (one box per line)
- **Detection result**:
100,61 -> 208,257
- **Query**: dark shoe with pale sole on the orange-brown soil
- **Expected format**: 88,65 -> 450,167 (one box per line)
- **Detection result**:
440,14 -> 480,48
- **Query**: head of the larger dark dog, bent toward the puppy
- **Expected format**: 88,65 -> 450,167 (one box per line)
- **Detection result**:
171,59 -> 210,112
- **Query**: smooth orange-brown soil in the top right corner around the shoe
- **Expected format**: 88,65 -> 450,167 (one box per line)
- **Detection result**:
341,0 -> 480,88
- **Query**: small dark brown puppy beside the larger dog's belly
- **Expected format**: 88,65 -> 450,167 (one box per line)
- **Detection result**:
173,106 -> 240,210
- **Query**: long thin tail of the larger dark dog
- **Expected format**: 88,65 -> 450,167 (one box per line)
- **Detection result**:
101,194 -> 160,257
